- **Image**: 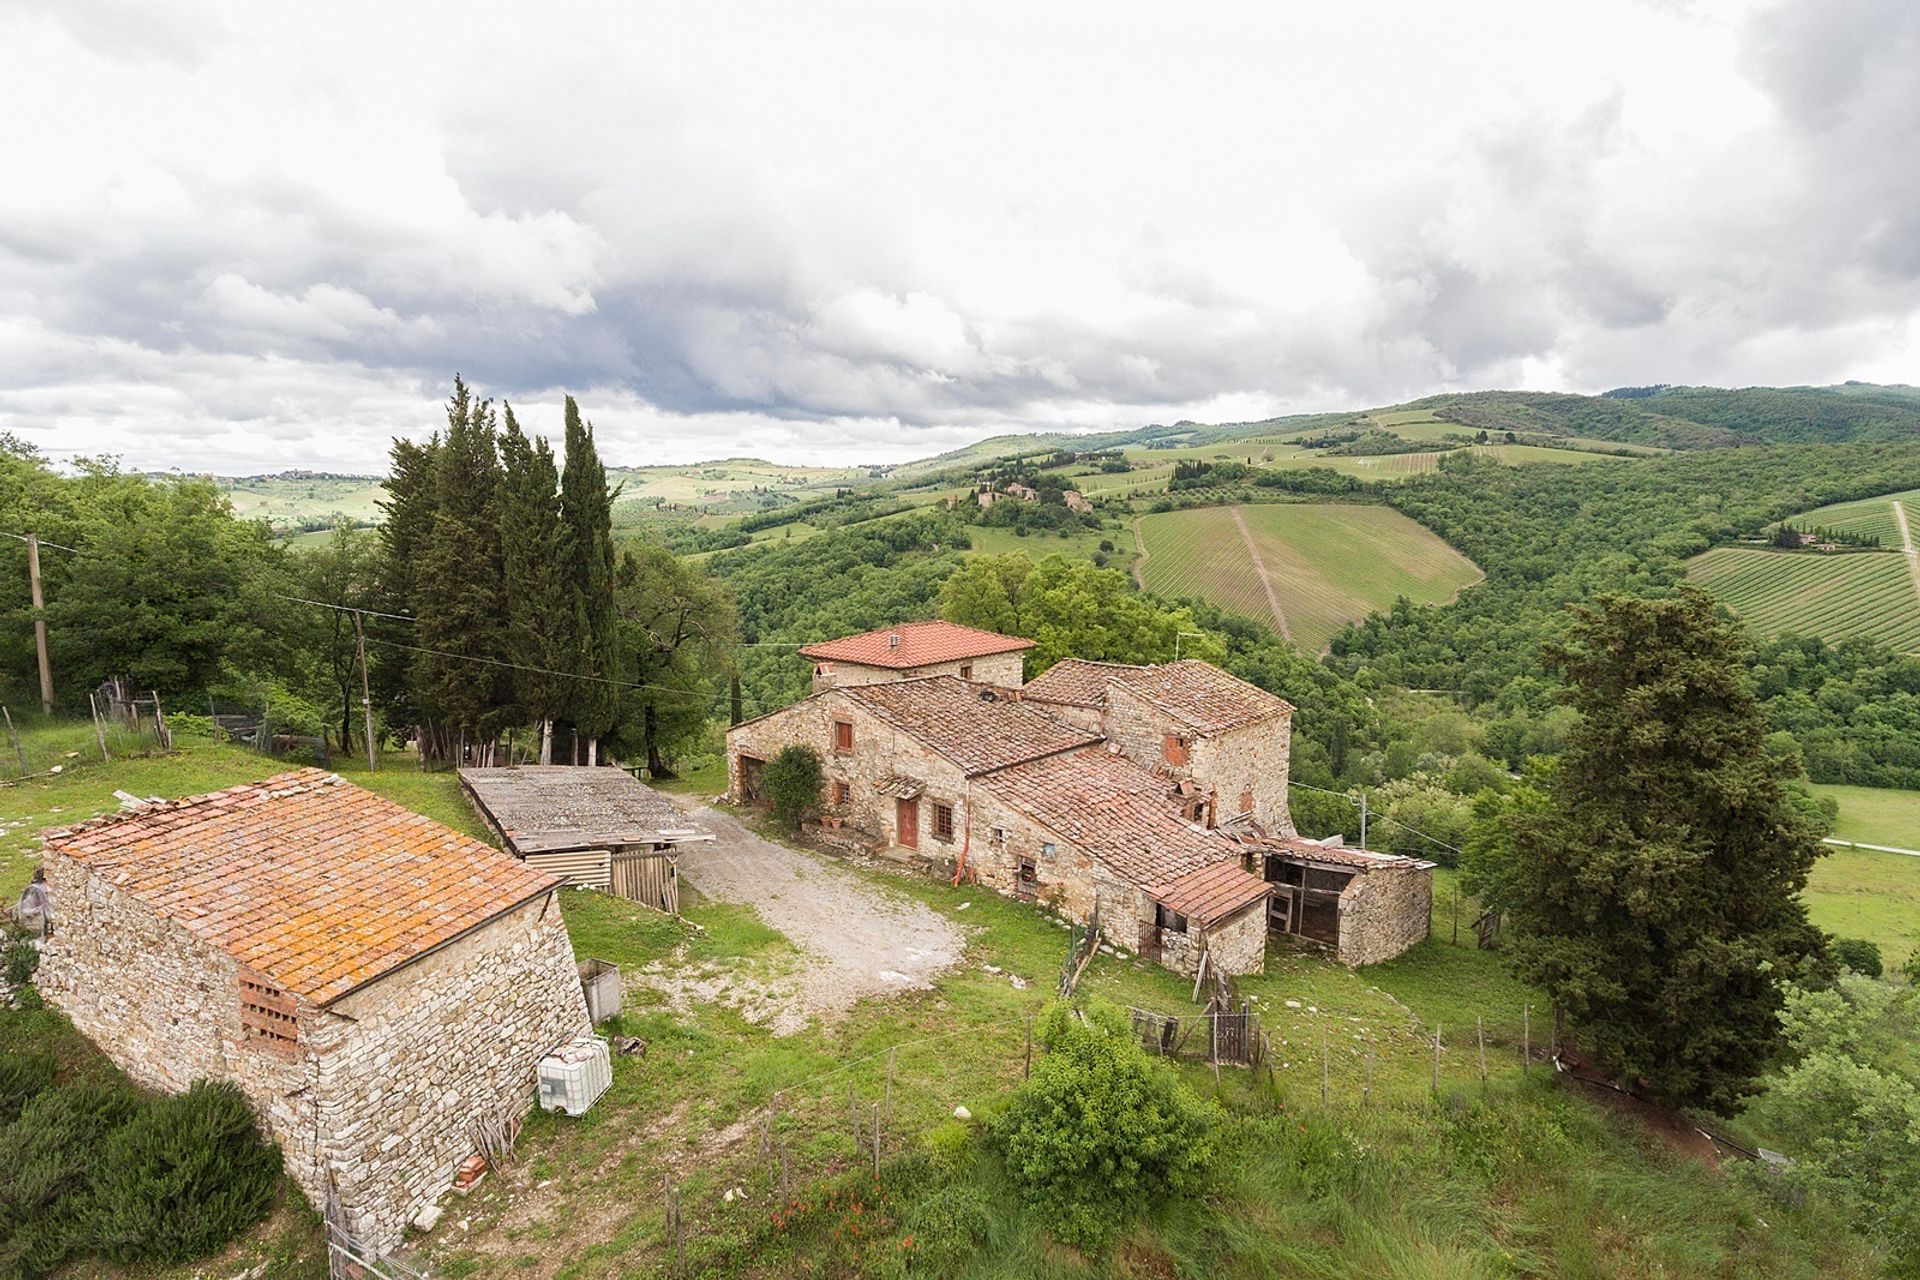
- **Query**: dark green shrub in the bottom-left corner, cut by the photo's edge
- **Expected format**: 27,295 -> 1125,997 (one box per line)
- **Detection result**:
0,1086 -> 136,1276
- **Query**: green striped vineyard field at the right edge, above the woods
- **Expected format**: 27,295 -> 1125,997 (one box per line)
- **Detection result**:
1688,547 -> 1920,652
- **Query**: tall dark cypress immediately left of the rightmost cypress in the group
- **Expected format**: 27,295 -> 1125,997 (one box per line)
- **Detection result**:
499,405 -> 578,764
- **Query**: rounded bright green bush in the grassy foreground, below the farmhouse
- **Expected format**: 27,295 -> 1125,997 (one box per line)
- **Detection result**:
996,1006 -> 1215,1247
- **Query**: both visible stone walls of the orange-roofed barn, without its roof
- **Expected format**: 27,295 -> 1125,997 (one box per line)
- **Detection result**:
38,850 -> 589,1249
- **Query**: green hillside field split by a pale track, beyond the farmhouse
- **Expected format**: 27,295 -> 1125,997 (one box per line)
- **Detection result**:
1135,503 -> 1480,652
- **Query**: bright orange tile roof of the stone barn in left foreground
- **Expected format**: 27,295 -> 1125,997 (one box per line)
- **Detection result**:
46,770 -> 559,1004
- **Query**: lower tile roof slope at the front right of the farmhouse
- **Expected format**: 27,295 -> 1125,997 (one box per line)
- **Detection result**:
979,747 -> 1240,889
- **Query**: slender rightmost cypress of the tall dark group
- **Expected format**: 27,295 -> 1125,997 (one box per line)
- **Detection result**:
561,395 -> 620,762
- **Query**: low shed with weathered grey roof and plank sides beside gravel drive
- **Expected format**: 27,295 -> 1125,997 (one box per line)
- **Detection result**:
461,764 -> 714,913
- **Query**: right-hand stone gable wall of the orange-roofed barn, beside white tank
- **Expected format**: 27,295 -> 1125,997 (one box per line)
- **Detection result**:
307,894 -> 591,1249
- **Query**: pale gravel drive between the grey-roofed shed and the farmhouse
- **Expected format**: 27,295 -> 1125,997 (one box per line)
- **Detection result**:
674,796 -> 966,1034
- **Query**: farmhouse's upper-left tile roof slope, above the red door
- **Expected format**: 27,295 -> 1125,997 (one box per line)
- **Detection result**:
840,676 -> 1100,773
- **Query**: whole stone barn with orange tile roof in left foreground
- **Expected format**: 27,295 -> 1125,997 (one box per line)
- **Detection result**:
38,770 -> 591,1249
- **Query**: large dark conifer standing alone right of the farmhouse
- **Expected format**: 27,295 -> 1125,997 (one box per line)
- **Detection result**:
1509,587 -> 1824,1111
